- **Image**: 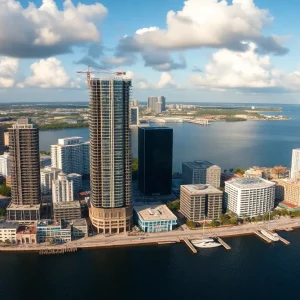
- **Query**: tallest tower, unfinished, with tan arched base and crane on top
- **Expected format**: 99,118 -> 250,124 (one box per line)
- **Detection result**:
89,78 -> 132,234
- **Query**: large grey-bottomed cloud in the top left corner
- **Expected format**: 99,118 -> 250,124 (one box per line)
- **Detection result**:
0,0 -> 107,57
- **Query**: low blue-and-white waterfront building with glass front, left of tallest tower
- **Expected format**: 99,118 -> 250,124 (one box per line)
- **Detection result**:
37,220 -> 71,243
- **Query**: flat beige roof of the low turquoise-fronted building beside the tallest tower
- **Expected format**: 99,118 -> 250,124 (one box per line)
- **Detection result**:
133,204 -> 177,221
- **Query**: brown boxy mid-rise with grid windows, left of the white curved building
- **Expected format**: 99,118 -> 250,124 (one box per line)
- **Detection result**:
180,184 -> 223,222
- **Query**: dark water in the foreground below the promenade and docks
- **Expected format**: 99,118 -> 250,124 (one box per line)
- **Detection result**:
0,230 -> 300,300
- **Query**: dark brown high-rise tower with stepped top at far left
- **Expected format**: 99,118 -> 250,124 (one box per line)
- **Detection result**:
7,119 -> 41,221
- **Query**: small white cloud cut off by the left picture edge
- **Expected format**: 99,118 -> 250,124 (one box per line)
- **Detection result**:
0,56 -> 19,89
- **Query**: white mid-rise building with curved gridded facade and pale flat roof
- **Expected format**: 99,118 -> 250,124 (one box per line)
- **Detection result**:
225,178 -> 275,218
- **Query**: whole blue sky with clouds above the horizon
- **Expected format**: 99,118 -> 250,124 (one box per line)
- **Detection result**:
0,0 -> 300,104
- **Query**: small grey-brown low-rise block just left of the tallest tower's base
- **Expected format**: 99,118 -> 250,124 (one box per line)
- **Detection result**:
53,201 -> 81,221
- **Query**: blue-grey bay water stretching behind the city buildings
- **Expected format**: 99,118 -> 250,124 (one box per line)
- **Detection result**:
40,105 -> 300,172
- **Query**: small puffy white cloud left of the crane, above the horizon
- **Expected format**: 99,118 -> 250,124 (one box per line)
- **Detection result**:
18,57 -> 80,88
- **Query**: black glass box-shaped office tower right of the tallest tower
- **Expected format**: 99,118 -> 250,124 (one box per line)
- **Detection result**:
138,127 -> 173,196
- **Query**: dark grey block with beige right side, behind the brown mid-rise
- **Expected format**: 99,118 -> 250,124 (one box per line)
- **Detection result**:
182,160 -> 221,188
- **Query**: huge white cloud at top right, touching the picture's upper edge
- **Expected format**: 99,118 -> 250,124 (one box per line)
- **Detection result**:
118,0 -> 288,54
